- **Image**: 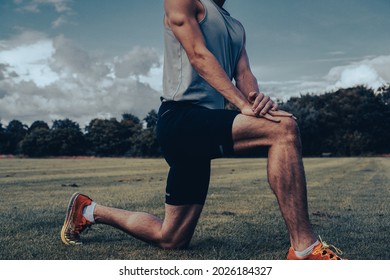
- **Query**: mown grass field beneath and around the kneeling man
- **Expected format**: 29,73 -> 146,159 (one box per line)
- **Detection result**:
0,158 -> 390,260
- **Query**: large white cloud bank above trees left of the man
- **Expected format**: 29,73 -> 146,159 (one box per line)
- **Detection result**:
0,31 -> 162,126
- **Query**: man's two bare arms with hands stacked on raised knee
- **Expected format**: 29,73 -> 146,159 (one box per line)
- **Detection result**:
164,0 -> 291,122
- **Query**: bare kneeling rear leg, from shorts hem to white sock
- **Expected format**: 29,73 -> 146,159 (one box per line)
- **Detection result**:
94,204 -> 203,249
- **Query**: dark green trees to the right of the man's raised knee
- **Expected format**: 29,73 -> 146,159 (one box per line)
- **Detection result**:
281,86 -> 390,156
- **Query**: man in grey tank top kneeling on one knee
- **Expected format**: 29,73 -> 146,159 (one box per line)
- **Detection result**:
61,0 -> 340,259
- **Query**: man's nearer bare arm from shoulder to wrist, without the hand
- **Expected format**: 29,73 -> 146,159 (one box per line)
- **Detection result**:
164,0 -> 253,115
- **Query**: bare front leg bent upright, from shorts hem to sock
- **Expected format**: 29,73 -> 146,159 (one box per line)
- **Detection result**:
233,115 -> 317,251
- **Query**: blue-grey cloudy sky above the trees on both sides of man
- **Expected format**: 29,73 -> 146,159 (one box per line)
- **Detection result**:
0,0 -> 390,126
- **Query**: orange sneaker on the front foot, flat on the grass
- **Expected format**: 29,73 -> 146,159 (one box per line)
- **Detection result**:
287,239 -> 345,260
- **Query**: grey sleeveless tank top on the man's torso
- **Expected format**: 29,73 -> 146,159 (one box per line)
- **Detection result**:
161,0 -> 245,109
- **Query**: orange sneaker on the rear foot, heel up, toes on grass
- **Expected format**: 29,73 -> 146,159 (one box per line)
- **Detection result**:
61,192 -> 92,245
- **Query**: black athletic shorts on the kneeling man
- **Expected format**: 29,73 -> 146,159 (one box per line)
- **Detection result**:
157,102 -> 239,205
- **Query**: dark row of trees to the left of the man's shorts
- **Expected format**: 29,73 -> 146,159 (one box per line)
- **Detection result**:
0,110 -> 161,157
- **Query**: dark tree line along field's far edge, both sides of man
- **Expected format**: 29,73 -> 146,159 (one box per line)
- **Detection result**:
0,86 -> 390,157
